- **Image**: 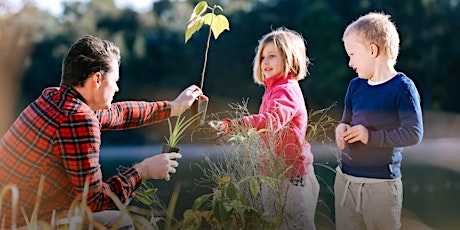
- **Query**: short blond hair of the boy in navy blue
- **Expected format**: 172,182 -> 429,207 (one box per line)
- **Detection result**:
342,12 -> 399,65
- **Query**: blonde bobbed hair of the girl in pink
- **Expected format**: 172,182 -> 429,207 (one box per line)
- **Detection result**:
253,27 -> 310,85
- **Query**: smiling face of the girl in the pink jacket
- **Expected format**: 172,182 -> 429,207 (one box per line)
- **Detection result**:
260,42 -> 284,79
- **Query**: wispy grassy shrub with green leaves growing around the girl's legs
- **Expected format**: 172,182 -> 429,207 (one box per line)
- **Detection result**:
178,100 -> 336,229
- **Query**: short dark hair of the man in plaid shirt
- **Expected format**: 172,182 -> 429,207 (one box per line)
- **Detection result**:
61,35 -> 120,86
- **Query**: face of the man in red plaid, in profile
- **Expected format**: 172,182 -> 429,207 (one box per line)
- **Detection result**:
95,59 -> 120,109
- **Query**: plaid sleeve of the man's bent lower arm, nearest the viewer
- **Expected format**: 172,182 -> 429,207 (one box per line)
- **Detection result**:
56,110 -> 141,211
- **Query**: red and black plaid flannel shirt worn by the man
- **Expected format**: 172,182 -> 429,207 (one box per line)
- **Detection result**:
0,87 -> 171,226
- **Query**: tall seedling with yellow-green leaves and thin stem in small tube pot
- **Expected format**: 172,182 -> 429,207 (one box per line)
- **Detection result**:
185,1 -> 230,126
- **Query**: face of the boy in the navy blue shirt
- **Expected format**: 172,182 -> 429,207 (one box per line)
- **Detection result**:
343,33 -> 374,79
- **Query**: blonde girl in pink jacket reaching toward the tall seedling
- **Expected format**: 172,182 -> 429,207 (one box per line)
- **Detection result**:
210,28 -> 319,229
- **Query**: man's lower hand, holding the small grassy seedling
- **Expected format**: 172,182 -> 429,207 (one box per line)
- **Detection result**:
134,153 -> 182,181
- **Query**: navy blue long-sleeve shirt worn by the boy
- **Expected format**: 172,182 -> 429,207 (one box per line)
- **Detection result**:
340,73 -> 423,179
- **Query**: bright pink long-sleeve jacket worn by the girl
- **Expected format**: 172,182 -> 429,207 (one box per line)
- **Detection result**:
234,75 -> 313,177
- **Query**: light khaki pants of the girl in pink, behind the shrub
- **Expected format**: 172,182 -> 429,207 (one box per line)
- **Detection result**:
261,171 -> 319,230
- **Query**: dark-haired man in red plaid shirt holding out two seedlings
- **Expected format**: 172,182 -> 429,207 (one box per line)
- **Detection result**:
0,35 -> 202,228
